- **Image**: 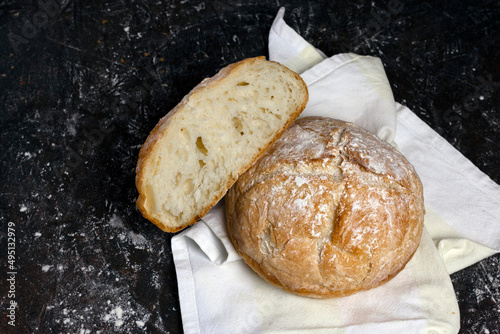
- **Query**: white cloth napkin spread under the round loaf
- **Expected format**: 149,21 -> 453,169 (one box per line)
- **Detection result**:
172,9 -> 500,334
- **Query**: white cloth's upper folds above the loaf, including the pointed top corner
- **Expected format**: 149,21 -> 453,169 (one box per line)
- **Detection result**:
269,8 -> 396,143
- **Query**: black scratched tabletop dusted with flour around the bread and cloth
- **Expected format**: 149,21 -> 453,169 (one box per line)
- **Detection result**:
0,0 -> 500,333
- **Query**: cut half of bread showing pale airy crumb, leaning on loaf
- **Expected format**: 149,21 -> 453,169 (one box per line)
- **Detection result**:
136,57 -> 308,232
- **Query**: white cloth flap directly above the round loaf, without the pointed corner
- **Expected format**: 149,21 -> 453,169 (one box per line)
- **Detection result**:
301,53 -> 396,143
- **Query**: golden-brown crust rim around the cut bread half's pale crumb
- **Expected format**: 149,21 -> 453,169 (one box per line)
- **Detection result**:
135,56 -> 308,233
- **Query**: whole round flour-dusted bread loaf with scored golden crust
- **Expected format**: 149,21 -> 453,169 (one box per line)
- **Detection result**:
226,117 -> 425,298
